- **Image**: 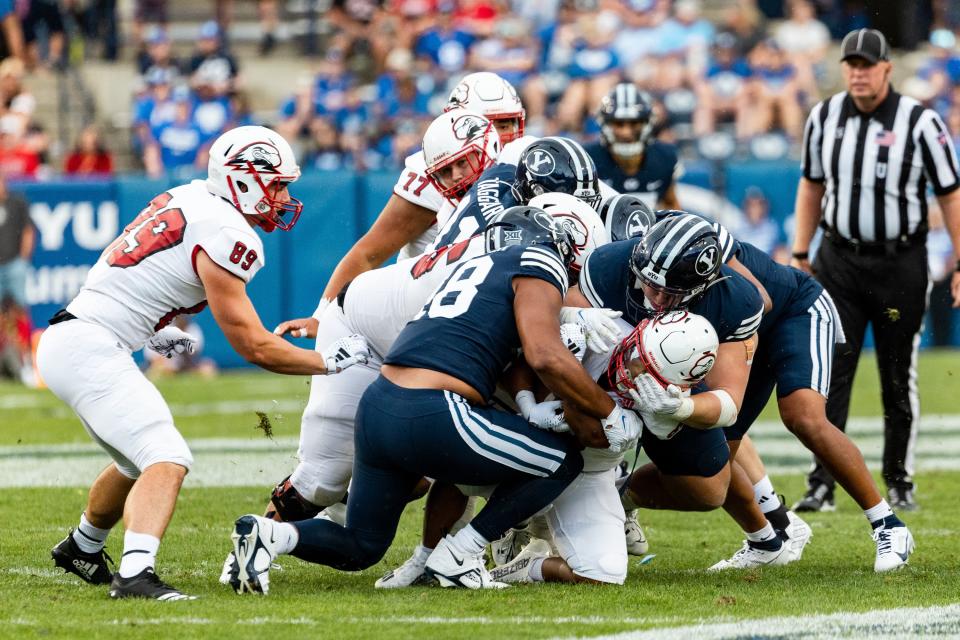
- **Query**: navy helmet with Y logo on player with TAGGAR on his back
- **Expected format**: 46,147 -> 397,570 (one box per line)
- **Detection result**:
513,137 -> 600,209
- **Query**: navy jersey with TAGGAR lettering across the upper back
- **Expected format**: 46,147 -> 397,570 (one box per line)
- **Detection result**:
432,164 -> 520,248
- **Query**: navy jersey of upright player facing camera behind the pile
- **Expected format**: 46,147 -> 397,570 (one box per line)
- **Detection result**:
584,140 -> 681,209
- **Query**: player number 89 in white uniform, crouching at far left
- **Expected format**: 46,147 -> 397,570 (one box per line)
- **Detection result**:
37,127 -> 366,601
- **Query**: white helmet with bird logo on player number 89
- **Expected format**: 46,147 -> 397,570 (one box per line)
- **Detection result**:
207,126 -> 303,231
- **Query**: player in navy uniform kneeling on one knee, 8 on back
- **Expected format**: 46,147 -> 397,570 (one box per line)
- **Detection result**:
233,207 -> 640,592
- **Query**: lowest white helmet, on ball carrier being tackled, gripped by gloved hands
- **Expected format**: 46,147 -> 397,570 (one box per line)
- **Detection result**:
607,311 -> 720,399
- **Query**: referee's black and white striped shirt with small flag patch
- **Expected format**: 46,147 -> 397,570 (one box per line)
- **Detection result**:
802,88 -> 960,242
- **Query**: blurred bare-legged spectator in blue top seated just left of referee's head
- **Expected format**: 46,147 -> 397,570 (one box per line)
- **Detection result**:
737,40 -> 803,140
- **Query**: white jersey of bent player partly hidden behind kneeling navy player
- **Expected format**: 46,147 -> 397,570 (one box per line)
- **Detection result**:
343,234 -> 486,358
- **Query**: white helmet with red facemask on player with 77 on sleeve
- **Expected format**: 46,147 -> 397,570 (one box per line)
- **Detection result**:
423,109 -> 500,204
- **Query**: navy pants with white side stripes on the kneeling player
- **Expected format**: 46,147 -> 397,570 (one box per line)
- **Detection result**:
293,376 -> 583,571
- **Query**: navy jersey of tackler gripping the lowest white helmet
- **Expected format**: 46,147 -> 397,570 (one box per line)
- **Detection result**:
579,238 -> 763,342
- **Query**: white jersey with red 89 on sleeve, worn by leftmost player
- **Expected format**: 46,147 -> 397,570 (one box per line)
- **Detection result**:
67,180 -> 264,351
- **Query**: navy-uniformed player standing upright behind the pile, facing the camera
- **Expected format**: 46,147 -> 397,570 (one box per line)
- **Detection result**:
585,82 -> 683,209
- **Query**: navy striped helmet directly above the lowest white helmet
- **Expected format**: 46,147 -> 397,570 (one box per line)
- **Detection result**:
630,211 -> 722,311
